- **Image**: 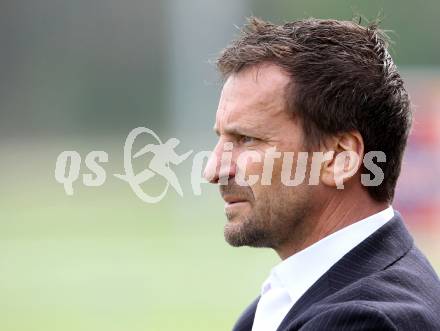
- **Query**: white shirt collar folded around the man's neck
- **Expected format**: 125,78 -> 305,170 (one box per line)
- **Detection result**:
261,206 -> 394,303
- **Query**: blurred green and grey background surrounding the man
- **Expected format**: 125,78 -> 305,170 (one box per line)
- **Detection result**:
0,0 -> 440,331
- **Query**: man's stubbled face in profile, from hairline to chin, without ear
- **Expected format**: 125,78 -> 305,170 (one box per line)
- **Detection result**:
205,64 -> 311,248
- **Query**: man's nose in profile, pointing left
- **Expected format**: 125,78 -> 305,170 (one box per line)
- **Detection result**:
203,142 -> 236,185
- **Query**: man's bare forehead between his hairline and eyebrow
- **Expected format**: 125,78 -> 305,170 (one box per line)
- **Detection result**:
215,64 -> 290,132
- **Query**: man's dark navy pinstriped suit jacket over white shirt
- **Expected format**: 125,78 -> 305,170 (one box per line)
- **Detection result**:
233,213 -> 440,331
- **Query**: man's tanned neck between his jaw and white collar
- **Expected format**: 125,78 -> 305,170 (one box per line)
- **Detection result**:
275,191 -> 389,260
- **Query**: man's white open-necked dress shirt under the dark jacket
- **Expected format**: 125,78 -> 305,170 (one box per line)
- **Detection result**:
252,206 -> 394,331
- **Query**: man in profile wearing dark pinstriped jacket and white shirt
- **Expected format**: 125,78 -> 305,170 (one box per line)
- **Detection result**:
205,18 -> 440,331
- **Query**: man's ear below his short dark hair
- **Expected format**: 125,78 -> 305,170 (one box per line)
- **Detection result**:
321,131 -> 364,189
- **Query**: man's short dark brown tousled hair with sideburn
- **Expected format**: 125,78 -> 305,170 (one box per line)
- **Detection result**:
217,17 -> 412,202
